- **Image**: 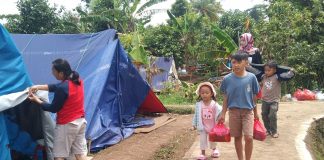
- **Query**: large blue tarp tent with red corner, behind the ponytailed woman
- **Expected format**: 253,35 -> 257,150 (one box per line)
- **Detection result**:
12,30 -> 166,150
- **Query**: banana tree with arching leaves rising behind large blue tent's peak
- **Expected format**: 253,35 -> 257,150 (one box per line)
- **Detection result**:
81,0 -> 165,33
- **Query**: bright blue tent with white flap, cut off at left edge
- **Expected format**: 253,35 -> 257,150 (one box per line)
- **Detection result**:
0,25 -> 54,160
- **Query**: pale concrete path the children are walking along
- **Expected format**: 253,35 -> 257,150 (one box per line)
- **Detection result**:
183,101 -> 324,160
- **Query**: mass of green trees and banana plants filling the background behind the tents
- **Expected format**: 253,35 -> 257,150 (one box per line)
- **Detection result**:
0,0 -> 324,96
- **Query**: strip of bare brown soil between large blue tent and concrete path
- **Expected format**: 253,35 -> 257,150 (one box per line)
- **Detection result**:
93,115 -> 197,160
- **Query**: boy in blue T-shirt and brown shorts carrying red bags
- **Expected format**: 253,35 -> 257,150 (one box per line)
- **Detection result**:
219,53 -> 260,160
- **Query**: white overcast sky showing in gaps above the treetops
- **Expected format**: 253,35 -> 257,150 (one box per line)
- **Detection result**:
0,0 -> 265,24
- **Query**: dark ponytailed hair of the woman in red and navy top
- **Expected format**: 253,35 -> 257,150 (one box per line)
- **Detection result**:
52,58 -> 80,85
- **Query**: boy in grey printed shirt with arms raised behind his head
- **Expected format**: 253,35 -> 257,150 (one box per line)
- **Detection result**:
261,61 -> 294,138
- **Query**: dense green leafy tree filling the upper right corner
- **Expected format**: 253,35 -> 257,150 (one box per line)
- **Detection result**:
257,0 -> 324,90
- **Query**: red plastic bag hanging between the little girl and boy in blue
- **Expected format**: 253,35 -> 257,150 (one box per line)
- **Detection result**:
209,123 -> 231,142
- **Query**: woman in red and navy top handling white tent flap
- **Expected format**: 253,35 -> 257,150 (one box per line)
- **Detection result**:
29,59 -> 87,160
